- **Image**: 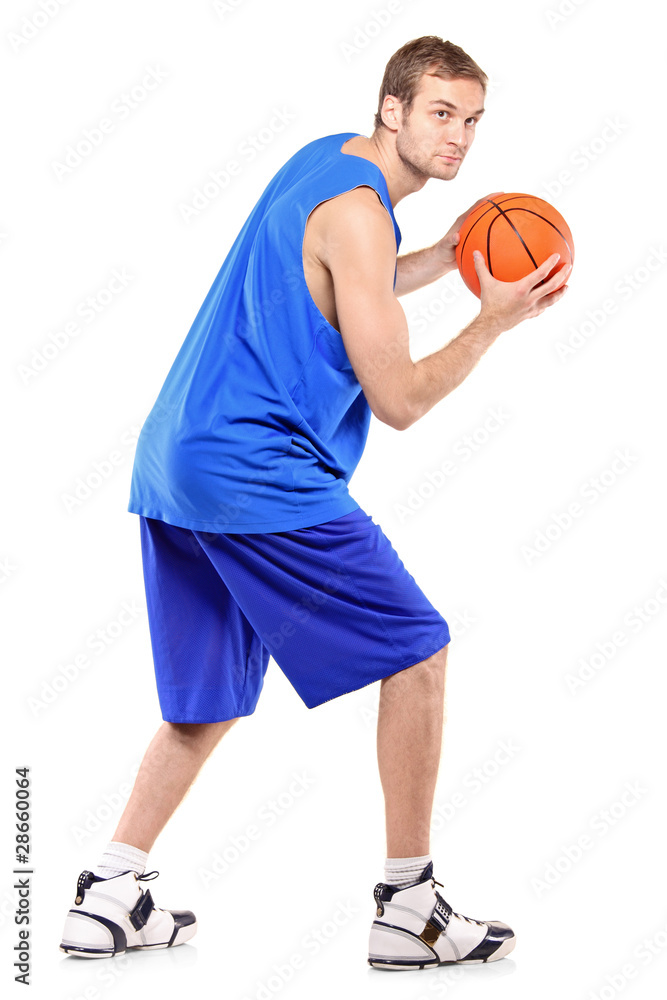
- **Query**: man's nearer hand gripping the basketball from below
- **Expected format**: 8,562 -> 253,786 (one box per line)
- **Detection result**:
473,251 -> 572,333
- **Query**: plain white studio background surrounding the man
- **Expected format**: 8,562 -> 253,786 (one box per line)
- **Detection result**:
0,0 -> 667,1000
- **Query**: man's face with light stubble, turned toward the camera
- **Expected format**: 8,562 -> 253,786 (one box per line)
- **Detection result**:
396,73 -> 484,181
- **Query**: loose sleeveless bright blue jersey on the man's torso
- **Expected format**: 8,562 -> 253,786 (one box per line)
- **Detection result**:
129,139 -> 401,533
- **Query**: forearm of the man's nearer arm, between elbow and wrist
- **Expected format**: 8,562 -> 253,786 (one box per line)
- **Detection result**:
406,313 -> 503,426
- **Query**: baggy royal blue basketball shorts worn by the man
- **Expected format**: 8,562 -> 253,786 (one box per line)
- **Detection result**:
140,508 -> 449,722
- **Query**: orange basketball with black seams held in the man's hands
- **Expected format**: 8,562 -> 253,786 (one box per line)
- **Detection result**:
456,194 -> 574,298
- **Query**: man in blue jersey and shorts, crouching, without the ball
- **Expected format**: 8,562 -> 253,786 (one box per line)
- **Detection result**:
61,36 -> 568,969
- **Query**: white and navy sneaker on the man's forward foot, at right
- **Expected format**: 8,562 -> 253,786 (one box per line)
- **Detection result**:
368,861 -> 516,970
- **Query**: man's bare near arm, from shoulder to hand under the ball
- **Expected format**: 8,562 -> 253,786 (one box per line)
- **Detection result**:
321,187 -> 566,430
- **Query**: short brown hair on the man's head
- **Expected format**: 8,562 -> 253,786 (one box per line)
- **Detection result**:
373,35 -> 488,128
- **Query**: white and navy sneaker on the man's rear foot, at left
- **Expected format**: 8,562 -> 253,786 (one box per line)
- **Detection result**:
60,871 -> 197,958
